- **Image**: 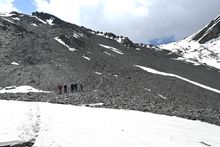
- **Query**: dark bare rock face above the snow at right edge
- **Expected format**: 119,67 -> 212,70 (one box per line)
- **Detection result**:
192,16 -> 220,44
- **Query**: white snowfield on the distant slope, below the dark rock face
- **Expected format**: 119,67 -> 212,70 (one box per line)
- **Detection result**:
160,36 -> 220,69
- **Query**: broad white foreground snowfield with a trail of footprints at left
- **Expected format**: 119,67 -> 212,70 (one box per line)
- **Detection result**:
0,100 -> 220,147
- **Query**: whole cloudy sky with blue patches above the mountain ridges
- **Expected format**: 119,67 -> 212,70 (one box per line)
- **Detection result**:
0,0 -> 220,44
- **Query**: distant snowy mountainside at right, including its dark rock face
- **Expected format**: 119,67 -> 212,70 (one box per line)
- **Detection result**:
160,16 -> 220,69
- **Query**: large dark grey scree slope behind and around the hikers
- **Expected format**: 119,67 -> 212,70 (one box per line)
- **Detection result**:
0,12 -> 220,125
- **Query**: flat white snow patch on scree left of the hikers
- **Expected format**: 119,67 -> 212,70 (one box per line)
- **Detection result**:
0,85 -> 48,93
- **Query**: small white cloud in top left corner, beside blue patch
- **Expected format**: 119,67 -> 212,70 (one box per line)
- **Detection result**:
0,0 -> 17,13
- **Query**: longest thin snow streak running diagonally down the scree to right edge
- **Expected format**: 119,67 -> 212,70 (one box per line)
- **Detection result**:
134,65 -> 220,93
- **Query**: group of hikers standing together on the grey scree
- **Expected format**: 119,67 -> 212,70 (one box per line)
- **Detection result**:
58,84 -> 83,94
